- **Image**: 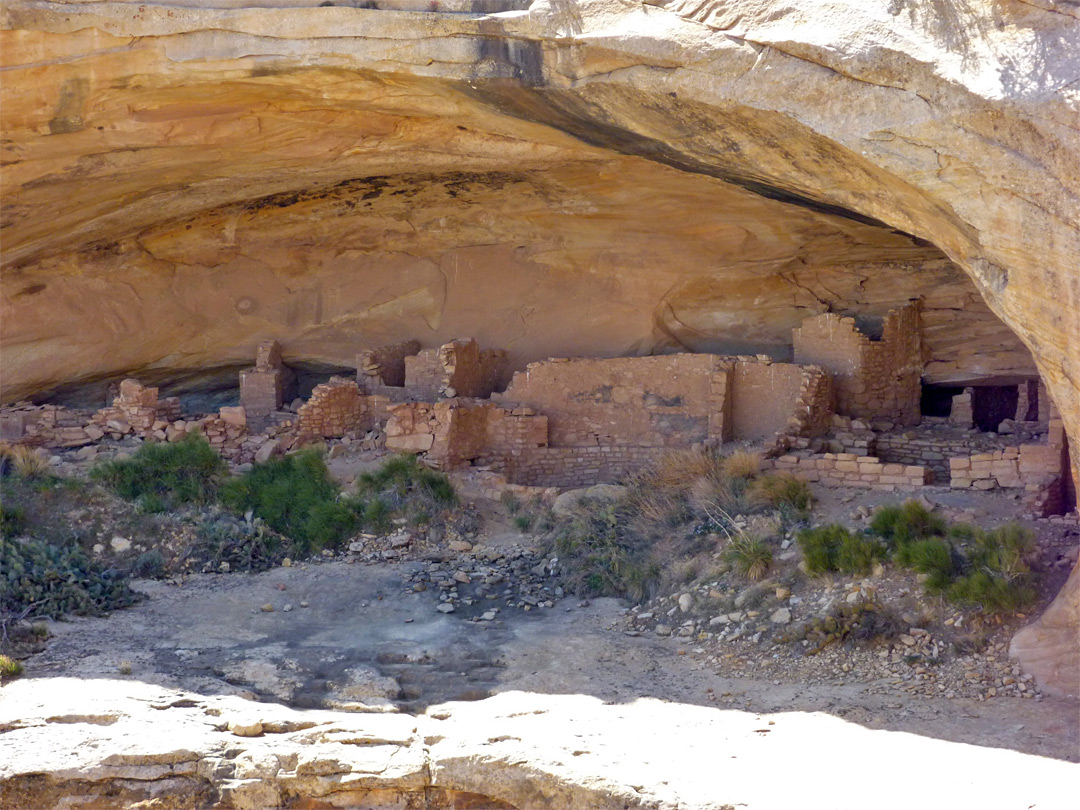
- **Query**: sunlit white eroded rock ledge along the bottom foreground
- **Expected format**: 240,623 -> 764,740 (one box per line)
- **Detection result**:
0,678 -> 1076,810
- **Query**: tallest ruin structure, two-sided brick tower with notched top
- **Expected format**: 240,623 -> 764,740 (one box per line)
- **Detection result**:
793,303 -> 924,424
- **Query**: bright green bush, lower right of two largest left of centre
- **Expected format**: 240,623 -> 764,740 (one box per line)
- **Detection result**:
220,450 -> 360,554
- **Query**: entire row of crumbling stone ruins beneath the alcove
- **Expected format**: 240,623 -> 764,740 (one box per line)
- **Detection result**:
0,311 -> 1076,514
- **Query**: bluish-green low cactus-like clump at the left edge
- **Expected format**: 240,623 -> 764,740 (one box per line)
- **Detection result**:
0,538 -> 138,619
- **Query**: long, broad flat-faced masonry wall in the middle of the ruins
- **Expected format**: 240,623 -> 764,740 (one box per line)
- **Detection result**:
491,354 -> 731,447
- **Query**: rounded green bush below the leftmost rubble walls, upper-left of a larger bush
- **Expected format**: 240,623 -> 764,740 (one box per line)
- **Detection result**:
91,435 -> 226,511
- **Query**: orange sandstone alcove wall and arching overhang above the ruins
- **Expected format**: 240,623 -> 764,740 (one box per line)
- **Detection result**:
0,0 -> 1080,695
